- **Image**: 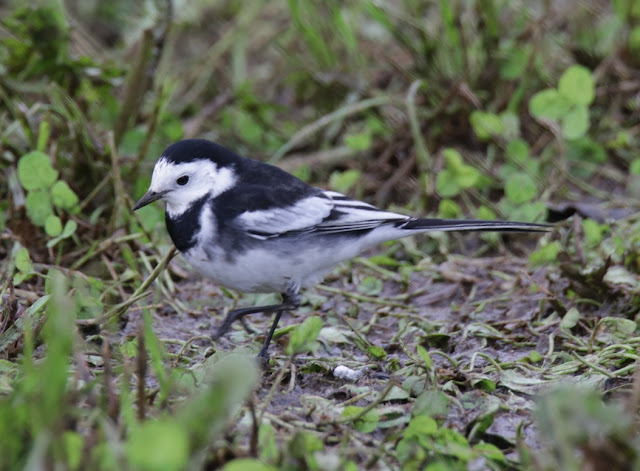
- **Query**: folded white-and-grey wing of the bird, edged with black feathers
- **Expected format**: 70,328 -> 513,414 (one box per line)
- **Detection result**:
237,191 -> 410,239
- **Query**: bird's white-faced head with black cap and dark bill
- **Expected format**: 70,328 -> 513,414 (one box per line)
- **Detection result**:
133,139 -> 240,216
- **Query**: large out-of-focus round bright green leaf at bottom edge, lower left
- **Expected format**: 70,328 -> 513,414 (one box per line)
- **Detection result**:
126,419 -> 189,471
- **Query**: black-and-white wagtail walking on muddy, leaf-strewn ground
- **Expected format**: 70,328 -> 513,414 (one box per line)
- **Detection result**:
133,139 -> 550,360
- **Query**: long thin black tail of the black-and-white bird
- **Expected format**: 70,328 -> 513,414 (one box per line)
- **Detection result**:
396,218 -> 553,232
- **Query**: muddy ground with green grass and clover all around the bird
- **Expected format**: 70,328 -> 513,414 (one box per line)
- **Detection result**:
0,0 -> 640,471
